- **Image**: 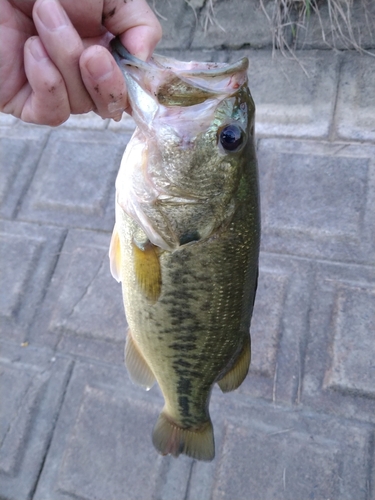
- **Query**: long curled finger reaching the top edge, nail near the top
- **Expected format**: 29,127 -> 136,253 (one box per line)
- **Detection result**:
33,0 -> 94,113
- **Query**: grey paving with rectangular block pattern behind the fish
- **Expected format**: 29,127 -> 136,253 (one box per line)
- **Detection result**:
0,45 -> 375,500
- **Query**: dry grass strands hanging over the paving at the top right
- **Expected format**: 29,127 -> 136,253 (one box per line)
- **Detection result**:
186,0 -> 375,76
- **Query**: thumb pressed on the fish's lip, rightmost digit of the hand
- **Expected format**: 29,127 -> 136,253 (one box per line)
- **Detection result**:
103,0 -> 162,60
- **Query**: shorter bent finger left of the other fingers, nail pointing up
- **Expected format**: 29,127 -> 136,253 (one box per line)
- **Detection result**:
19,36 -> 70,126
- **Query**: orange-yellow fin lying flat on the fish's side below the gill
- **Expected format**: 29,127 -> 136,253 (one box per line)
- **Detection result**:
133,242 -> 161,302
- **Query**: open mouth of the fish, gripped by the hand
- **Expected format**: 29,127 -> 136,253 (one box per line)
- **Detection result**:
111,38 -> 249,107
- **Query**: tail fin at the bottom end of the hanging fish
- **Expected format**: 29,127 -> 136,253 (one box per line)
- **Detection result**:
152,410 -> 215,461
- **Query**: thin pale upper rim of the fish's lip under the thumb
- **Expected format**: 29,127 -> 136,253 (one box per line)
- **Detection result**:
110,37 -> 249,78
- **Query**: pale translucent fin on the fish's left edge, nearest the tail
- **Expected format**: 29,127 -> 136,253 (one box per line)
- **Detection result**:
125,330 -> 155,391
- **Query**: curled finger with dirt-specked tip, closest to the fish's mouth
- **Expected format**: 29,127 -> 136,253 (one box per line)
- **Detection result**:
80,45 -> 128,120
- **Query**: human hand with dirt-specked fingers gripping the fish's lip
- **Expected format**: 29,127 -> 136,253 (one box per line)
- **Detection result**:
0,0 -> 161,126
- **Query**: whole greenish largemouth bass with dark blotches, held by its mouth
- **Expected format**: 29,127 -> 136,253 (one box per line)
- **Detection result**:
109,39 -> 260,461
